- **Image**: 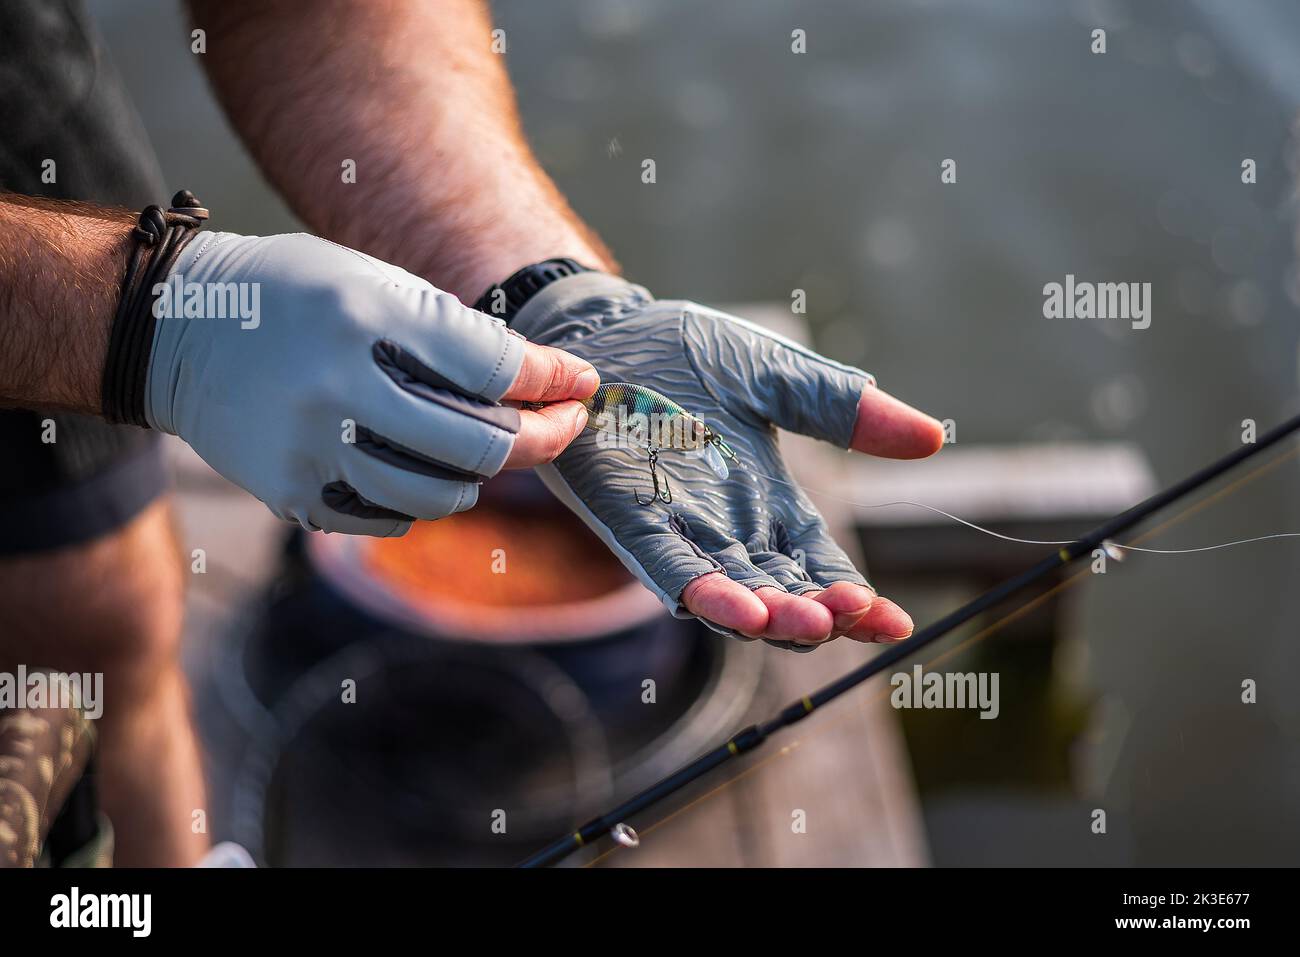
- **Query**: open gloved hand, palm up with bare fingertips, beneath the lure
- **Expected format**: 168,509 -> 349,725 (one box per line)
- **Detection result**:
511,273 -> 943,650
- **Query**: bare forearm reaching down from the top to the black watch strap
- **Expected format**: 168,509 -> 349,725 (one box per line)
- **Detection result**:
190,0 -> 615,302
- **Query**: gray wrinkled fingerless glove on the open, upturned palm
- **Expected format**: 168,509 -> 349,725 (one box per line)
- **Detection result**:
511,272 -> 872,650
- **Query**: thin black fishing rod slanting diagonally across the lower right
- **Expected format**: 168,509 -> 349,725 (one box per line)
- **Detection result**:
519,415 -> 1300,867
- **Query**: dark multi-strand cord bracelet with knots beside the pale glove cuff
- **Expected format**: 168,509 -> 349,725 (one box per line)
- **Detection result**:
100,190 -> 208,428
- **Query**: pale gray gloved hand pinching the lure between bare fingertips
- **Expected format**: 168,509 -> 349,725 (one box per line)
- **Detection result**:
144,233 -> 598,536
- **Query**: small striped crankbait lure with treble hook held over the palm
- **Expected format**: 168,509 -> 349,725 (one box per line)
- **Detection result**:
582,382 -> 740,505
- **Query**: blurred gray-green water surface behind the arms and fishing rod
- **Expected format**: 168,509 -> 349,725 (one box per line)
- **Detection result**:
92,0 -> 1300,865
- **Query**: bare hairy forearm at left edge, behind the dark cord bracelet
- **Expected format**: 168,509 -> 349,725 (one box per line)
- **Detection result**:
0,195 -> 134,413
